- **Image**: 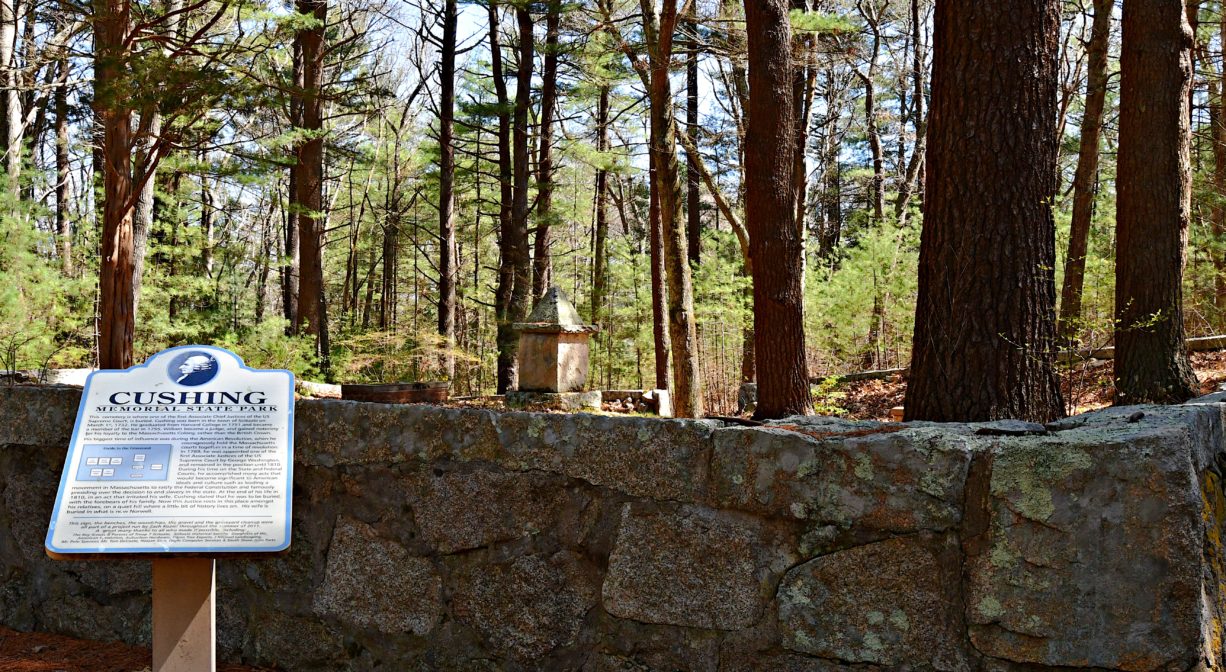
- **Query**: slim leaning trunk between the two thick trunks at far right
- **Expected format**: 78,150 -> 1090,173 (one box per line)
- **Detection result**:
1057,0 -> 1116,340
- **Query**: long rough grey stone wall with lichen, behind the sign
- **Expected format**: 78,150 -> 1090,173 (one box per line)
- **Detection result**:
0,388 -> 1226,671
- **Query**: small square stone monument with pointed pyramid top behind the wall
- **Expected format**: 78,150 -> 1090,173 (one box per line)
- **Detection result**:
506,287 -> 601,411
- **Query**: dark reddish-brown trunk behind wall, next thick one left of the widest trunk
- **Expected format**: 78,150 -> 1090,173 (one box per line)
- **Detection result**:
745,0 -> 813,418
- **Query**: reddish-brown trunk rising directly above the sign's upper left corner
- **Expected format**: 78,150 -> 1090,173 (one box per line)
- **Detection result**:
93,0 -> 136,369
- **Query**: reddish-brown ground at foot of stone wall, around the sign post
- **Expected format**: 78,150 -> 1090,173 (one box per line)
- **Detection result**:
0,627 -> 272,672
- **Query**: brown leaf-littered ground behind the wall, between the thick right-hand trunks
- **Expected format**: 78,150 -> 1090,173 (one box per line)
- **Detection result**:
833,352 -> 1226,421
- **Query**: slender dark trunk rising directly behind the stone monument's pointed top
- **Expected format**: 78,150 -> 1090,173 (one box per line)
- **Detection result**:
532,0 -> 562,300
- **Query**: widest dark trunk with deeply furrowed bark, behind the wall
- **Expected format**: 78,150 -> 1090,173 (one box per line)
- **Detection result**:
906,0 -> 1063,422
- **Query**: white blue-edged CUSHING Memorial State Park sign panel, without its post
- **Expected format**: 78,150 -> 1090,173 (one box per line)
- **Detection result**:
47,346 -> 294,556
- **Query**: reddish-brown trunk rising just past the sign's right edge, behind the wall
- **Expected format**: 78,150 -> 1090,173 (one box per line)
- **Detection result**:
294,0 -> 327,375
